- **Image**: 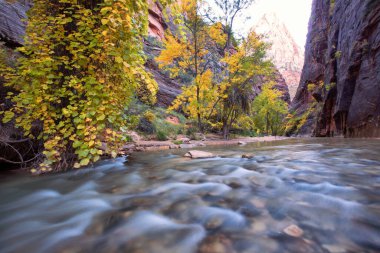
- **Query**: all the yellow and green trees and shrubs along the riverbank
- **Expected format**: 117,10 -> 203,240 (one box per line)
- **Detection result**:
0,0 -> 287,173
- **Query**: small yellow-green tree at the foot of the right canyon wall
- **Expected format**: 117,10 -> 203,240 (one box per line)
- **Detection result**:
252,82 -> 288,135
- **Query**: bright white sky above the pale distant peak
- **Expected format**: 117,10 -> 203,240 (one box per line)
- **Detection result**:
207,0 -> 312,48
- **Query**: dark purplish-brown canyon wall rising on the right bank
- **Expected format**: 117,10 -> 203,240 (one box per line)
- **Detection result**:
293,0 -> 380,137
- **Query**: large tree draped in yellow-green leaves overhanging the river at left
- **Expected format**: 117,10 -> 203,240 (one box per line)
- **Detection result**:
3,0 -> 168,172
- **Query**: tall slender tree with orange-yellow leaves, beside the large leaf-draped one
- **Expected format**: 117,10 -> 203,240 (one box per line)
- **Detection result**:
156,0 -> 225,131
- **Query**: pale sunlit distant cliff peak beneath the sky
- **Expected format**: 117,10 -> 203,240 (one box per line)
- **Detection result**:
253,13 -> 304,99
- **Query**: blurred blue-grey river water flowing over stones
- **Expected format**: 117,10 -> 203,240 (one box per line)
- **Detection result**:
0,139 -> 380,253
